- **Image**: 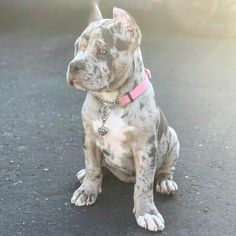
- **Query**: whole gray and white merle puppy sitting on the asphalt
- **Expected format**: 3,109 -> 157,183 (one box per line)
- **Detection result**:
67,5 -> 179,231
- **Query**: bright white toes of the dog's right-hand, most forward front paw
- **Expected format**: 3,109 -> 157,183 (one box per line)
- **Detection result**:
137,213 -> 165,231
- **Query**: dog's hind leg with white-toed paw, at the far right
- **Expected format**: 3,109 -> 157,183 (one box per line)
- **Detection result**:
156,127 -> 179,195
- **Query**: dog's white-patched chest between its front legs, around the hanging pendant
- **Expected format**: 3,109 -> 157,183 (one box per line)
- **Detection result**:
92,111 -> 135,169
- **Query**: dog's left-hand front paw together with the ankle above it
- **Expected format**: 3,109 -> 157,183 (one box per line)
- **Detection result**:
71,180 -> 102,206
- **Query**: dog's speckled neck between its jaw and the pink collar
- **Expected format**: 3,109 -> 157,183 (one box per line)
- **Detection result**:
93,47 -> 144,102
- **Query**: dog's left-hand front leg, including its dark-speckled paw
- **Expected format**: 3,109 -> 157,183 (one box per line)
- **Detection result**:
71,135 -> 103,206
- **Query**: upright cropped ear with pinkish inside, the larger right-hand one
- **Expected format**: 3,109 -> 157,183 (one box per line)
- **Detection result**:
113,7 -> 142,48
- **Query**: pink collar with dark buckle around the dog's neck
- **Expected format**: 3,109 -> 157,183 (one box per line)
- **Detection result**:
119,69 -> 151,106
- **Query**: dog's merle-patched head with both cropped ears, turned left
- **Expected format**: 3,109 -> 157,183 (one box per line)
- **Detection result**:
67,5 -> 141,92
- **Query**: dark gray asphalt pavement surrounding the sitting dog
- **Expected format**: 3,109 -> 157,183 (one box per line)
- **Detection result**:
0,4 -> 236,236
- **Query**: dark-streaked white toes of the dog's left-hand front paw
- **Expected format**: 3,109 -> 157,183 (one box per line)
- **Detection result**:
71,188 -> 98,206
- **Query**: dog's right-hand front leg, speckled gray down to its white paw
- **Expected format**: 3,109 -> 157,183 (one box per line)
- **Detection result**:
134,135 -> 165,231
